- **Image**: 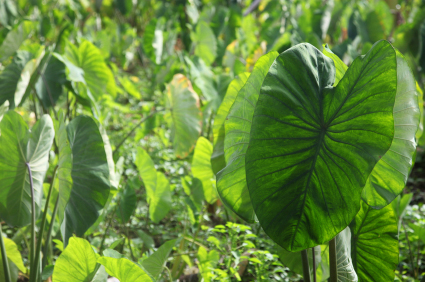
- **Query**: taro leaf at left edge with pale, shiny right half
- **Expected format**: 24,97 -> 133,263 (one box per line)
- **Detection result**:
0,111 -> 55,226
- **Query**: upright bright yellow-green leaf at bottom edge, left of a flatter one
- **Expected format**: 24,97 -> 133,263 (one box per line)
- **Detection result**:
52,237 -> 96,282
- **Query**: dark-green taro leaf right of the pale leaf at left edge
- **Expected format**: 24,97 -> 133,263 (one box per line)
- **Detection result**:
62,116 -> 110,245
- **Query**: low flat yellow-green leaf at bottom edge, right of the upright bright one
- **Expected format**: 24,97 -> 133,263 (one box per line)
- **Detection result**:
97,257 -> 155,282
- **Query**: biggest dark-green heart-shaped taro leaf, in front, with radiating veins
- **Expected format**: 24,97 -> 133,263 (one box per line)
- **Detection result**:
246,41 -> 397,251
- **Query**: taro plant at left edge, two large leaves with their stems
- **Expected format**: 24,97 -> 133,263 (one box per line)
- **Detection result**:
0,110 -> 110,282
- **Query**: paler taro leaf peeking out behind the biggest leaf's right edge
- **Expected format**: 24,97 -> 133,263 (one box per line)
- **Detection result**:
362,51 -> 421,209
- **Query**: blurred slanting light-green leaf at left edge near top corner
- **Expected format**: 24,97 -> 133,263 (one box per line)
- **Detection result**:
0,21 -> 35,62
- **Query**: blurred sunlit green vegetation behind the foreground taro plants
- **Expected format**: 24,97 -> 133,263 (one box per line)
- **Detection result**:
0,0 -> 425,282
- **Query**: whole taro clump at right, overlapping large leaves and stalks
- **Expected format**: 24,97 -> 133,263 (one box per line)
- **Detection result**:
213,41 -> 422,282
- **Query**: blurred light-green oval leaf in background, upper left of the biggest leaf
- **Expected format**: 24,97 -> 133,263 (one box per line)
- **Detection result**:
192,21 -> 217,65
